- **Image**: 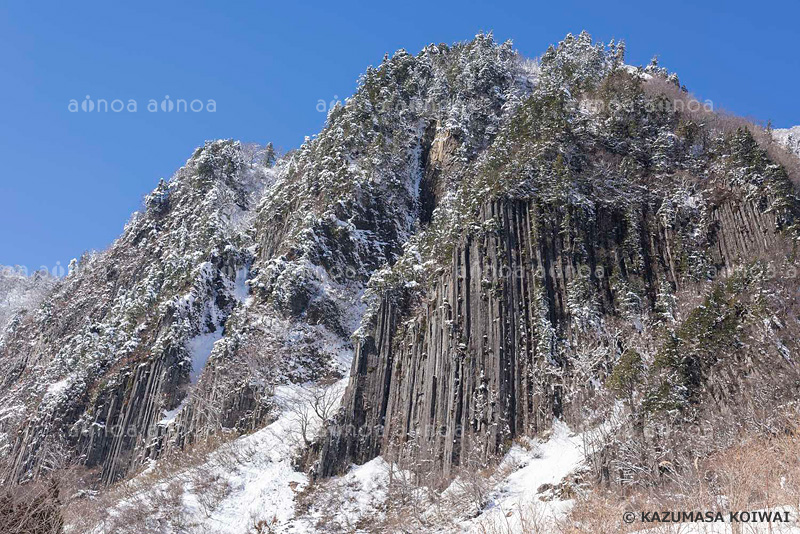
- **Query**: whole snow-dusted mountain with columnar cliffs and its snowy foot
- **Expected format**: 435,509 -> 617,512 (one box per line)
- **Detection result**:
0,33 -> 800,533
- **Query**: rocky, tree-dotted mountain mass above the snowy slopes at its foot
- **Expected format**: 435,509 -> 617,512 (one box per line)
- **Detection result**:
6,34 -> 800,506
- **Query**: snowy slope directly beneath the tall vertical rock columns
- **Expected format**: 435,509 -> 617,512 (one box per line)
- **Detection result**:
290,421 -> 587,534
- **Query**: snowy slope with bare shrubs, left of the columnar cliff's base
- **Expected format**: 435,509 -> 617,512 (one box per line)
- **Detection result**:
73,381 -> 344,534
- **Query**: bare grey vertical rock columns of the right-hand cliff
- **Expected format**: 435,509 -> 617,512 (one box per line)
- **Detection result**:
319,182 -> 782,476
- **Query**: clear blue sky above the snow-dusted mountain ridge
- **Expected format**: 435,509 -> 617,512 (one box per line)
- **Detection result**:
0,0 -> 800,268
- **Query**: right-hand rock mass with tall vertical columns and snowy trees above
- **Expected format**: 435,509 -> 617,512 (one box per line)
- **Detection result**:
318,36 -> 800,477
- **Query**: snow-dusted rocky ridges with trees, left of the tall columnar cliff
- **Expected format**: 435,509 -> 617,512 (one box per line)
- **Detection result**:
0,35 -> 531,484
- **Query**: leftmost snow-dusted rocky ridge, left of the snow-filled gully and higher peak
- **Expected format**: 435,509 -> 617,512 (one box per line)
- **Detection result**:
0,141 -> 271,483
